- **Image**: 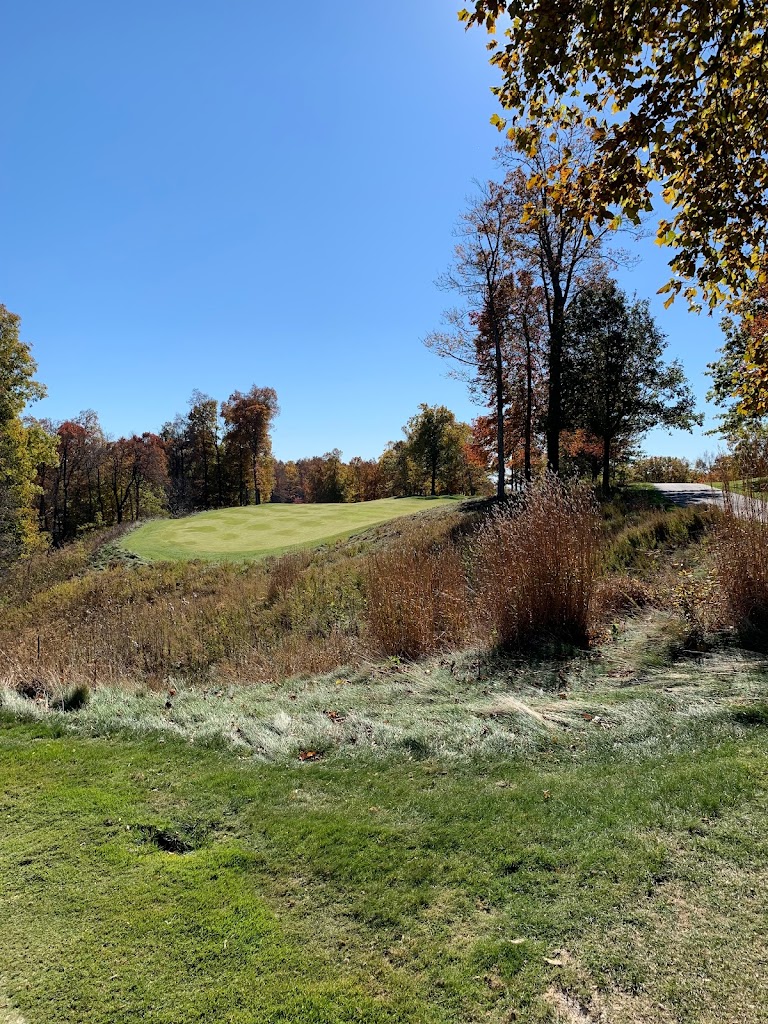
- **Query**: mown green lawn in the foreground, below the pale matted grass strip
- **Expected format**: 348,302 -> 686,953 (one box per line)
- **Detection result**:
0,696 -> 768,1024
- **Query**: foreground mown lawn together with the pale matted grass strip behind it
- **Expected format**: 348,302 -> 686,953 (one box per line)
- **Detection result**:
0,499 -> 768,1024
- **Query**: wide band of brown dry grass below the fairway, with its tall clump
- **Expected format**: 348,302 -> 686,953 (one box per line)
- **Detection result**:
0,480 -> 597,690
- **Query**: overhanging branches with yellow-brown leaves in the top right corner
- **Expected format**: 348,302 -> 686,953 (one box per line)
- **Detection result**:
459,0 -> 768,305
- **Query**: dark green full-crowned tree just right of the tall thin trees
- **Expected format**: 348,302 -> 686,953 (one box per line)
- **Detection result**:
563,280 -> 701,494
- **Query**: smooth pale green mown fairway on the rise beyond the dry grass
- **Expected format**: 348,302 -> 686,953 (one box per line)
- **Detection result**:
123,498 -> 464,561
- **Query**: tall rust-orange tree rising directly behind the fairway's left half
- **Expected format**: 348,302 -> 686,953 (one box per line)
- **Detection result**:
221,384 -> 280,505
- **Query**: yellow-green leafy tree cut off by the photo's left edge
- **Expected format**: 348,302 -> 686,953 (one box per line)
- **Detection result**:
0,304 -> 55,564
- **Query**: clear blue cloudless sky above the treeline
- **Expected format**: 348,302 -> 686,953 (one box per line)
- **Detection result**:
0,0 -> 720,459
